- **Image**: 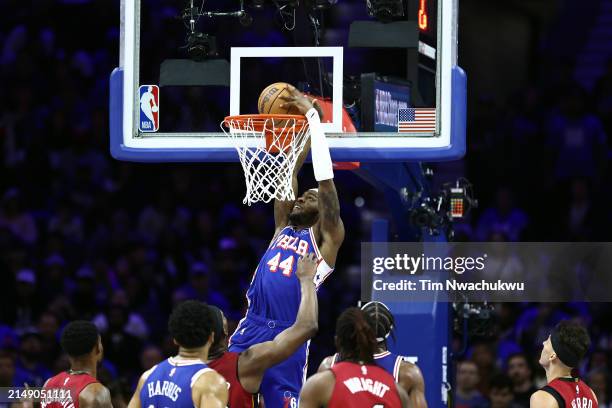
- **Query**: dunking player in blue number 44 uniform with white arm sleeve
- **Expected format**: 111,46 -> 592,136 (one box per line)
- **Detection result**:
230,83 -> 344,408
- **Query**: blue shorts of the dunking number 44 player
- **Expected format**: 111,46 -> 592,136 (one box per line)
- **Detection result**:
229,313 -> 309,408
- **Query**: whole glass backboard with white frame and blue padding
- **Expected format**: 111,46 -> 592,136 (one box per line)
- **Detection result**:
111,0 -> 466,162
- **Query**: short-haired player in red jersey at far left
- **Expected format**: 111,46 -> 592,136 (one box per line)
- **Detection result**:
41,320 -> 113,408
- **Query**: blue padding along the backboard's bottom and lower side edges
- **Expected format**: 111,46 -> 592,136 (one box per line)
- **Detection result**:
109,67 -> 467,163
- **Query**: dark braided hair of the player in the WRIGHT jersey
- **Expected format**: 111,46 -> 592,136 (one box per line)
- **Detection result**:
336,307 -> 377,363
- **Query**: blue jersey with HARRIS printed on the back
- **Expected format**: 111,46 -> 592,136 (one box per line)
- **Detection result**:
140,357 -> 212,408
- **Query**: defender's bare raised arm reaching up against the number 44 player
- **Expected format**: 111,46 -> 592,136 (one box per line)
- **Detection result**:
238,253 -> 319,392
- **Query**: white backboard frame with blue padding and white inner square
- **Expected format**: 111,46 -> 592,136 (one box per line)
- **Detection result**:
110,0 -> 466,162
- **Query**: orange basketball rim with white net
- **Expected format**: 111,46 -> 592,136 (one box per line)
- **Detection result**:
221,114 -> 310,205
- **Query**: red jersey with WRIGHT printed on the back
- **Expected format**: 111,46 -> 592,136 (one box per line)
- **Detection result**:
327,361 -> 402,408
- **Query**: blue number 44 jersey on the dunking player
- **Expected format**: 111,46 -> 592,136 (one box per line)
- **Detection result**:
247,226 -> 333,324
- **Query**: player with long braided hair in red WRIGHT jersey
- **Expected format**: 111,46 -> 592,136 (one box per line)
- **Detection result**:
299,307 -> 408,408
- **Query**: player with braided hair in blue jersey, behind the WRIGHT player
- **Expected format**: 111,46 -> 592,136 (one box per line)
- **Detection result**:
318,301 -> 427,408
